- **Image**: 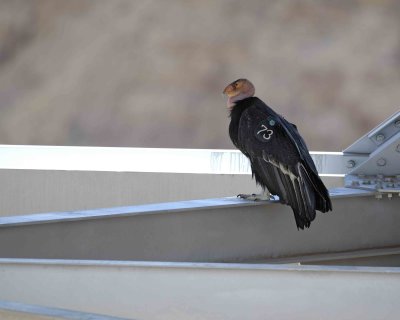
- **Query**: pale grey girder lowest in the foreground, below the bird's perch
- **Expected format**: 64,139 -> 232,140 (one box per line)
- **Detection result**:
0,259 -> 400,320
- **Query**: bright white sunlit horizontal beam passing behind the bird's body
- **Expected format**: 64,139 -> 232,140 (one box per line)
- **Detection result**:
0,145 -> 348,175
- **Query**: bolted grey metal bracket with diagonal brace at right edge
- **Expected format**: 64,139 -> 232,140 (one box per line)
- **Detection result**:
343,111 -> 400,198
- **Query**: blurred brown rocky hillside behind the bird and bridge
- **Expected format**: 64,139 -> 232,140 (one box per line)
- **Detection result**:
0,0 -> 400,151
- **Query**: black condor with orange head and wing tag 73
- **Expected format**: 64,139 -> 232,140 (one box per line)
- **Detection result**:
223,79 -> 332,229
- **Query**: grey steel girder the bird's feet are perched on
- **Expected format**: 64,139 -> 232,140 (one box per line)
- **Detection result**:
0,188 -> 400,262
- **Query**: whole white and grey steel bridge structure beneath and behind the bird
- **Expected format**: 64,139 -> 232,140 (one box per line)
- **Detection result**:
0,112 -> 400,319
